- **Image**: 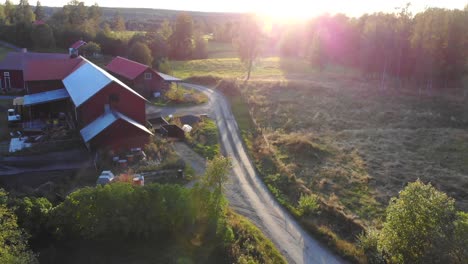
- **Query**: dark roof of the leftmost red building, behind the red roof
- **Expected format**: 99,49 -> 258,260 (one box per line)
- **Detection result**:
0,52 -> 69,70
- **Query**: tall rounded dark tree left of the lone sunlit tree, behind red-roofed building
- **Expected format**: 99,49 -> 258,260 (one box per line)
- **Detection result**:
169,13 -> 193,60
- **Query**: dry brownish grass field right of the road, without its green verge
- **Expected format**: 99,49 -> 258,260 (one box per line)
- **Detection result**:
244,74 -> 468,224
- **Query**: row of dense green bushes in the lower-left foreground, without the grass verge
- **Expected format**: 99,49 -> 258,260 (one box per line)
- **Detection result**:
0,157 -> 234,263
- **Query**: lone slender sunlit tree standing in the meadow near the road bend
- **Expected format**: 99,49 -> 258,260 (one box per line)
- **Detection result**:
234,15 -> 262,81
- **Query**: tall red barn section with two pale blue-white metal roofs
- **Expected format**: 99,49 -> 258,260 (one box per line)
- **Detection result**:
63,58 -> 152,149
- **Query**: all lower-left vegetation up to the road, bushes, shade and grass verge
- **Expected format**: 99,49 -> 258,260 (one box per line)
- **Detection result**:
0,157 -> 285,263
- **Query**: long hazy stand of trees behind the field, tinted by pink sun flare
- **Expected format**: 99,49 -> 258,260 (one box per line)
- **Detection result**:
272,4 -> 468,90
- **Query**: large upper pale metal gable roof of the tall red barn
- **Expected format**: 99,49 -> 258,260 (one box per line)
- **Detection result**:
63,58 -> 146,107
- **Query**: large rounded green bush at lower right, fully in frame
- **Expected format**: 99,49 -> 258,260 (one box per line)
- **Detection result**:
378,180 -> 460,263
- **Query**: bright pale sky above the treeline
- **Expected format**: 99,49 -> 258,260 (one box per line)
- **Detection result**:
20,0 -> 468,18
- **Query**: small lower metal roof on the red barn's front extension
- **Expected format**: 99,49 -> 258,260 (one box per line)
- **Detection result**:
80,111 -> 153,143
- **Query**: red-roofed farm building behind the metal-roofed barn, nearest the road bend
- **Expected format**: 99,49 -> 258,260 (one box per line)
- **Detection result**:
106,57 -> 181,98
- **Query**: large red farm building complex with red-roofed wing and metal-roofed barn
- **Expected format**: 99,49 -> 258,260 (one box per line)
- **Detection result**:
0,50 -> 152,150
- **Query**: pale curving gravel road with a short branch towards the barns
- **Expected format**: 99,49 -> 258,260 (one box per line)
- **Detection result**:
147,83 -> 345,263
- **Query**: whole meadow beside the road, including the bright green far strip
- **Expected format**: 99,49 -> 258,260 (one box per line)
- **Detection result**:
173,53 -> 468,260
